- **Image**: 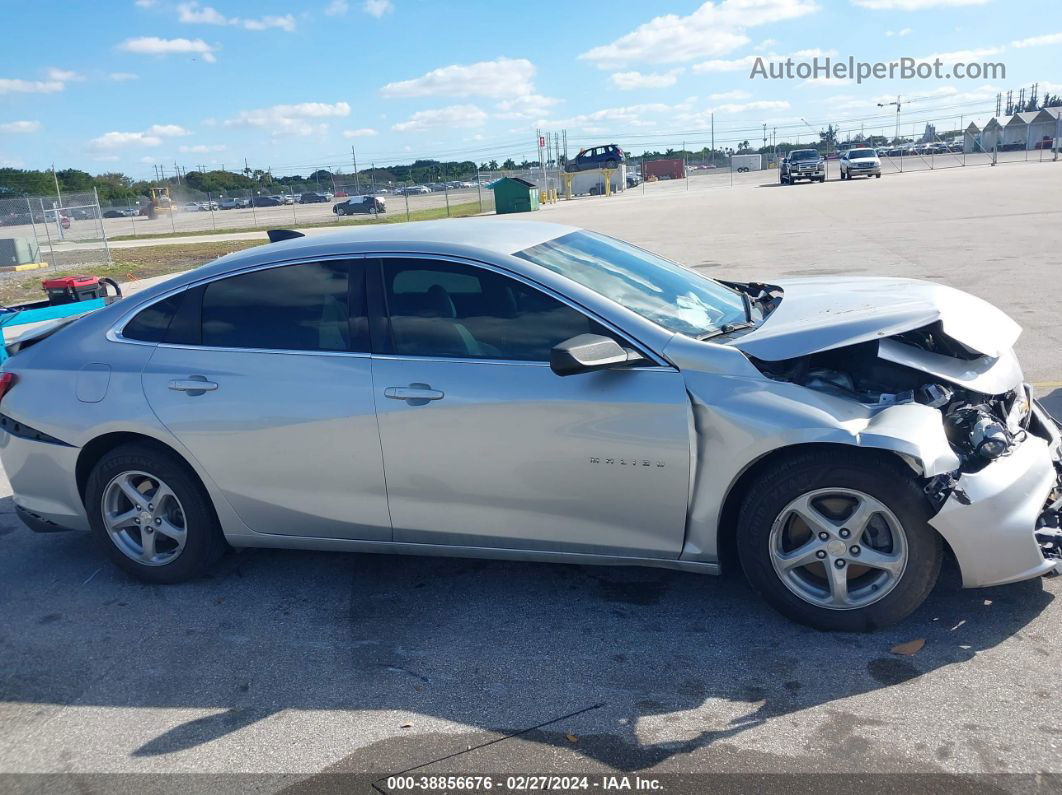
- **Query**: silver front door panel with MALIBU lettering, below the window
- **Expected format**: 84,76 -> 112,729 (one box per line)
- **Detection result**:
373,358 -> 689,557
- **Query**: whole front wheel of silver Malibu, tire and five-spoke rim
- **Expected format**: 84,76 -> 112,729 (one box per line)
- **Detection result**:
737,450 -> 943,632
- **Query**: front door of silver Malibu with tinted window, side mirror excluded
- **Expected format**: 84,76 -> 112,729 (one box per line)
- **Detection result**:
373,258 -> 690,557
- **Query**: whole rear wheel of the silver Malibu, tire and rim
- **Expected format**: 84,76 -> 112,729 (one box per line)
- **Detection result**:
85,444 -> 226,583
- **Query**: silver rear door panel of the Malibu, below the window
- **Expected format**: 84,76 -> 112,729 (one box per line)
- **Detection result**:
143,346 -> 391,540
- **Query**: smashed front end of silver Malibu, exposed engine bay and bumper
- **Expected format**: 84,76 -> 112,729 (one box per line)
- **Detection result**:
735,318 -> 1062,587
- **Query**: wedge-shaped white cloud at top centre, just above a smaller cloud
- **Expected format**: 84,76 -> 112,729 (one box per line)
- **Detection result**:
380,58 -> 534,98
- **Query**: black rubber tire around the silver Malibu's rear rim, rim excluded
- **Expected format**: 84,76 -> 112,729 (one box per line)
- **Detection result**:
85,443 -> 227,583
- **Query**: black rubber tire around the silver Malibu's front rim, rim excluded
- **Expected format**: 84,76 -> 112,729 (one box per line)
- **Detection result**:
737,448 -> 943,632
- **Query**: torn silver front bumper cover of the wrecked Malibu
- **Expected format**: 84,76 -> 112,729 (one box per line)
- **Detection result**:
929,428 -> 1059,588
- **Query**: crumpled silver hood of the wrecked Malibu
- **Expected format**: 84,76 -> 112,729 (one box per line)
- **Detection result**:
732,276 -> 1022,362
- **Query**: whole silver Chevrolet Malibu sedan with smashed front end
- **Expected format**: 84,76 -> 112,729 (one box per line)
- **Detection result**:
0,220 -> 1062,630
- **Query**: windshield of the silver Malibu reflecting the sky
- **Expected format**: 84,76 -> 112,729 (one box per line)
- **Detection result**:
515,231 -> 747,338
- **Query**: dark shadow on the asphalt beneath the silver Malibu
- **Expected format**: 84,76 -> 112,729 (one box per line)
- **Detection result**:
0,498 -> 1052,771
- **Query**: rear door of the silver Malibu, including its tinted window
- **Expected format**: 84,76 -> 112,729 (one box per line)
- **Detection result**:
143,259 -> 391,540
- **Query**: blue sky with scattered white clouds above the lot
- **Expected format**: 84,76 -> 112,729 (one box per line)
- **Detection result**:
0,0 -> 1062,177
